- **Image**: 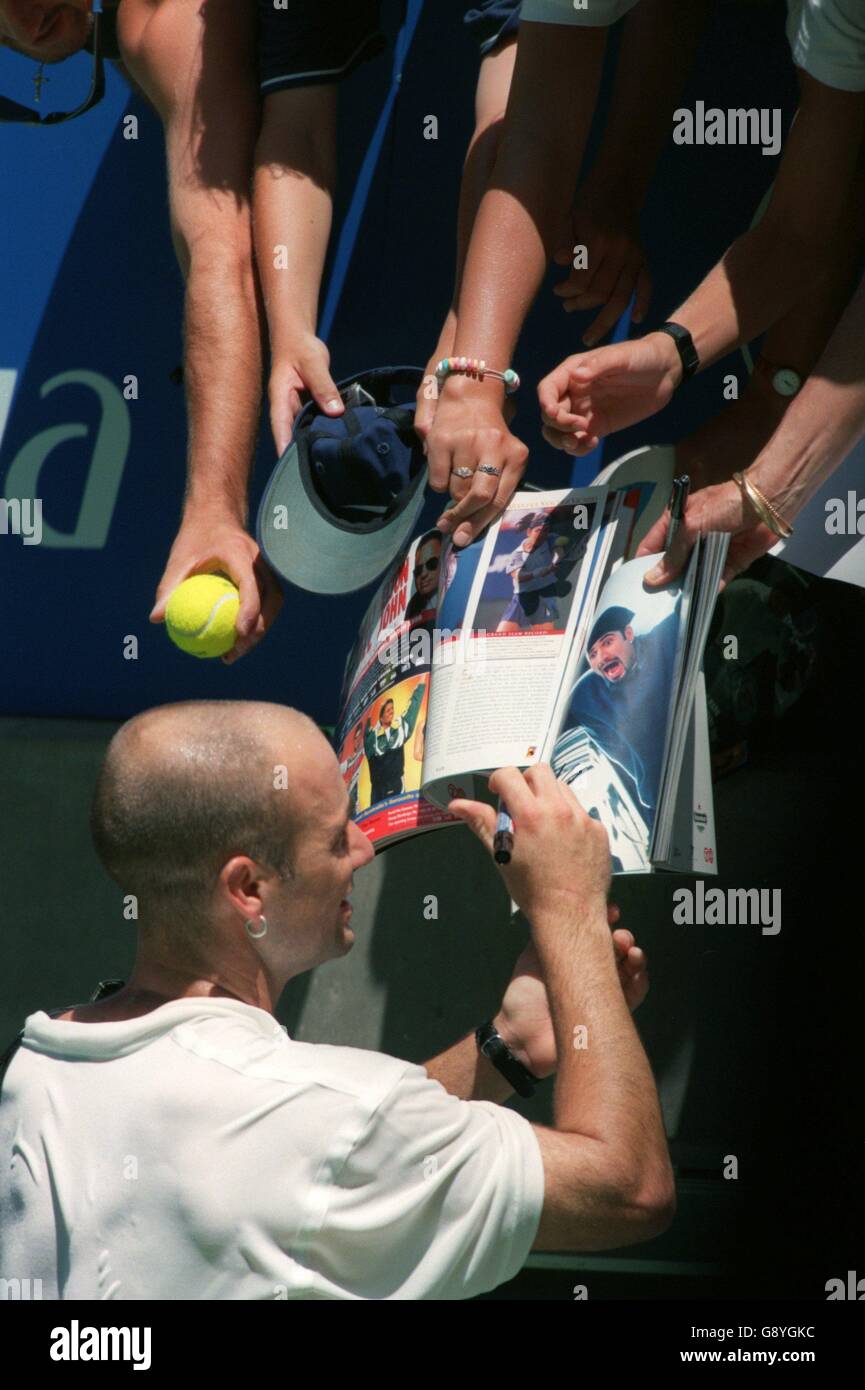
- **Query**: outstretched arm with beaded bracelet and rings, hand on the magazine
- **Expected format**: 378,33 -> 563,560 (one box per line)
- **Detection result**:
427,22 -> 606,545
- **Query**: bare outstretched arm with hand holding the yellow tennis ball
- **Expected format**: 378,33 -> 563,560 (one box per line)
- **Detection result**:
120,0 -> 281,656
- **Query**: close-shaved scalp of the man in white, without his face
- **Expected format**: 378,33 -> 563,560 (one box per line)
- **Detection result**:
90,701 -> 326,935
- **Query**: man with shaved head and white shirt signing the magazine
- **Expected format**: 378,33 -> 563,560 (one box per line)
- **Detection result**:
0,702 -> 673,1300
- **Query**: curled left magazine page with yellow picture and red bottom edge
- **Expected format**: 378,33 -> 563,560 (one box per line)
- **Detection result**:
334,531 -> 453,847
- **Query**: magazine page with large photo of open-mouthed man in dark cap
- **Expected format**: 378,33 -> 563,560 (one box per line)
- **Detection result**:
551,556 -> 693,873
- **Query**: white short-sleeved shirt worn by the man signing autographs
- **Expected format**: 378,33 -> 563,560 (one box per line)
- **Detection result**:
0,999 -> 544,1300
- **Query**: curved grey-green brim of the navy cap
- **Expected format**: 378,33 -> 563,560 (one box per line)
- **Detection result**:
257,443 -> 427,594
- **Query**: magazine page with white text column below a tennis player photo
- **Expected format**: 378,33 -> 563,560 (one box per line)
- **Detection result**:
424,488 -> 612,805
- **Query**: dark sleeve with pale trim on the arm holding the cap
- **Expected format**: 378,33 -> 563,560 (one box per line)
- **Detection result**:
259,0 -> 387,96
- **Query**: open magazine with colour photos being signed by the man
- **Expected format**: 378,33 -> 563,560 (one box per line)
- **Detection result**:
335,482 -> 727,873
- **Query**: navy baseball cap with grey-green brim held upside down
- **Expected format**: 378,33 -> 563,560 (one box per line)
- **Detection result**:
257,367 -> 427,594
